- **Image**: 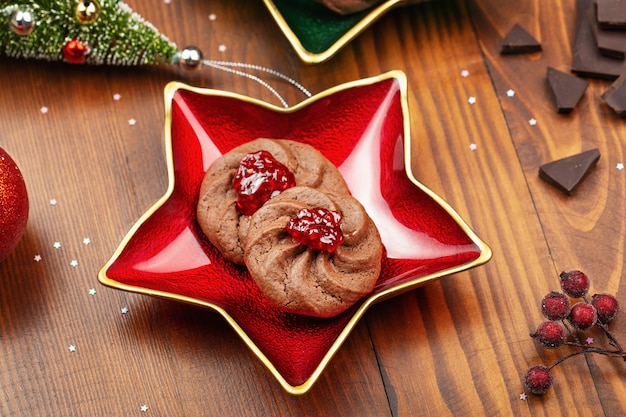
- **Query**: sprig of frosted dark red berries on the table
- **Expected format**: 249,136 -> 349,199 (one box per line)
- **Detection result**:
524,271 -> 626,395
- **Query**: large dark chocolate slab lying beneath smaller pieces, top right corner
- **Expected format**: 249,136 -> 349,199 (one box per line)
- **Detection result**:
572,0 -> 626,80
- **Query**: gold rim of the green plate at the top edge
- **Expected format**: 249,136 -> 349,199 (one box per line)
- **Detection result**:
263,0 -> 428,64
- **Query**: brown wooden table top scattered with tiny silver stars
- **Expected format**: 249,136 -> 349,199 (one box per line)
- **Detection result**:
0,0 -> 626,417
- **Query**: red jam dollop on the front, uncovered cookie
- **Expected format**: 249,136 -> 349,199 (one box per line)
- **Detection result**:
286,207 -> 343,253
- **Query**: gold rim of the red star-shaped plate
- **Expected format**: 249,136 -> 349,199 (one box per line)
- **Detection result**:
98,70 -> 492,395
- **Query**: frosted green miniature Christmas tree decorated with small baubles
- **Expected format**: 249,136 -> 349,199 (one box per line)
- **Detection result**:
0,0 -> 177,65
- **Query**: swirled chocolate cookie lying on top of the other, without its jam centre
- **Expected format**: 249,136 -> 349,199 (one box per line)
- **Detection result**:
244,187 -> 383,317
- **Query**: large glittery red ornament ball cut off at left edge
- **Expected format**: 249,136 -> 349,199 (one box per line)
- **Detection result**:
0,148 -> 28,262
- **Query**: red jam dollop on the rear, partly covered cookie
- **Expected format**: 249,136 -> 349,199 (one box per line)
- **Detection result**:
233,151 -> 296,216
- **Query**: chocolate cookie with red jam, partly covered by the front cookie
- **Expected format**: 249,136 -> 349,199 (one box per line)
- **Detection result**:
196,138 -> 349,264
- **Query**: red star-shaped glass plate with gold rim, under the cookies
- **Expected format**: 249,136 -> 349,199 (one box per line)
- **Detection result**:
98,71 -> 491,394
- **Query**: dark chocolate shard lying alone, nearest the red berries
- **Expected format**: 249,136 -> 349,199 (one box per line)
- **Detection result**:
539,149 -> 600,195
